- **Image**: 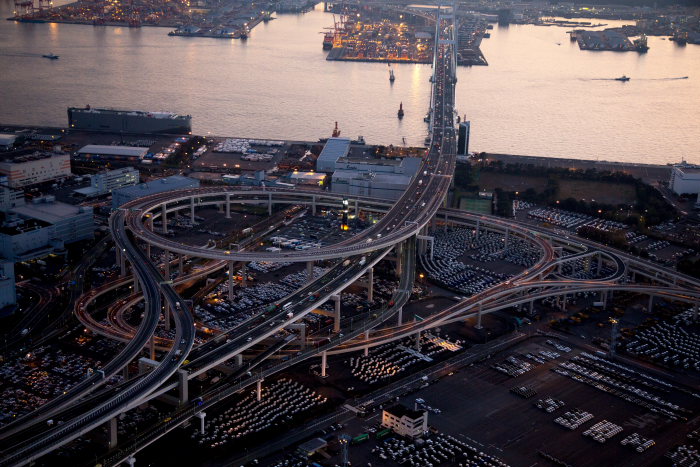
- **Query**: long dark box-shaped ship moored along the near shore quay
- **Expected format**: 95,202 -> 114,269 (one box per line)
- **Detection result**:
68,105 -> 192,135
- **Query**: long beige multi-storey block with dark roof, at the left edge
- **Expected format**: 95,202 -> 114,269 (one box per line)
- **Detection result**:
0,151 -> 71,188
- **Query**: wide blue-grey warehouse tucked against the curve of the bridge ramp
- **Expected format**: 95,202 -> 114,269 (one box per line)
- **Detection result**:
331,157 -> 421,199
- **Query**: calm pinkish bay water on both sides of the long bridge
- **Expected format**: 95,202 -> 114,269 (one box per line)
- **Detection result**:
0,0 -> 700,163
